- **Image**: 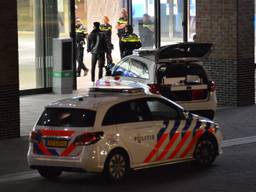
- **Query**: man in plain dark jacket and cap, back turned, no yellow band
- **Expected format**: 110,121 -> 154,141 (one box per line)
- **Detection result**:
87,22 -> 107,82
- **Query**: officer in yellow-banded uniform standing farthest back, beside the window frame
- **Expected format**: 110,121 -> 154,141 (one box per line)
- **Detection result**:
116,8 -> 128,57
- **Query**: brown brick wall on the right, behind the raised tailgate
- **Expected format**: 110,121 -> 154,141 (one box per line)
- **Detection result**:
196,0 -> 255,106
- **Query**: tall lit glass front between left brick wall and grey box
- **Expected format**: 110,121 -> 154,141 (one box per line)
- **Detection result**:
17,0 -> 70,90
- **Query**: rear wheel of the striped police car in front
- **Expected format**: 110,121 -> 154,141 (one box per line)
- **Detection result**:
104,151 -> 129,181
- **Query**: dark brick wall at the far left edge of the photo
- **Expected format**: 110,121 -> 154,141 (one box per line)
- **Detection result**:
0,0 -> 20,139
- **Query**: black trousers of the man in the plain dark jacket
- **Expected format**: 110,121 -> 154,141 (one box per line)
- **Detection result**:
91,53 -> 105,82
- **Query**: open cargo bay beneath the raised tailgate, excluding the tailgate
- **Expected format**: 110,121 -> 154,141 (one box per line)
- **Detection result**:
158,63 -> 209,101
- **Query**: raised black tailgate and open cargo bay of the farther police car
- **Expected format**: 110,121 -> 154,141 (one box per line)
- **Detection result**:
156,43 -> 212,101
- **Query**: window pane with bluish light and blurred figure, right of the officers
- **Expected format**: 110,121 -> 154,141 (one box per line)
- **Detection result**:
132,0 -> 155,48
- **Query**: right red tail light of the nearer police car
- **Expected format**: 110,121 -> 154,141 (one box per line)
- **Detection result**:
73,131 -> 104,146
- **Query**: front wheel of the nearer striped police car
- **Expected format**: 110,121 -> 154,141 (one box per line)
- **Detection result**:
194,137 -> 217,166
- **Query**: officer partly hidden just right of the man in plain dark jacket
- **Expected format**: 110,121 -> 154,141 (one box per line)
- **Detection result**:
100,16 -> 114,75
